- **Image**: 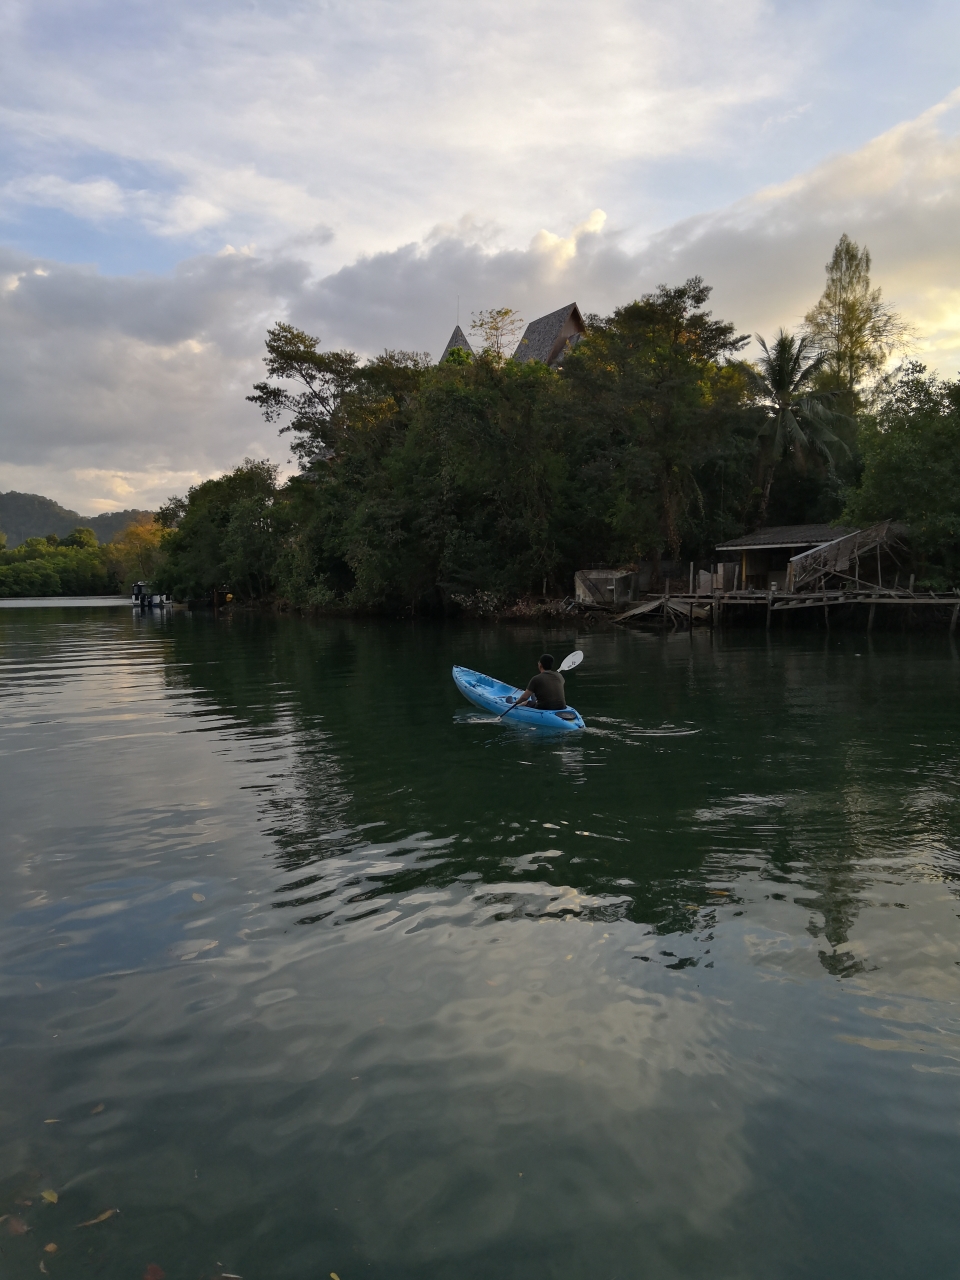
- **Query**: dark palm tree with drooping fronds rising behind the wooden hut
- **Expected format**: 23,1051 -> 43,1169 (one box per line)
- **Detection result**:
744,329 -> 850,527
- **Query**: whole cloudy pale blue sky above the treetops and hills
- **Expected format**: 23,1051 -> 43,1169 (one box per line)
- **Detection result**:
0,0 -> 960,515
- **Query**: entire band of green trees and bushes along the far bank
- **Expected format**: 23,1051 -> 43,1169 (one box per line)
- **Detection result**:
7,237 -> 960,612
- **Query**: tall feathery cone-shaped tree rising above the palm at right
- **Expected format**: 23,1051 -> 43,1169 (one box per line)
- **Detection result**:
804,232 -> 910,412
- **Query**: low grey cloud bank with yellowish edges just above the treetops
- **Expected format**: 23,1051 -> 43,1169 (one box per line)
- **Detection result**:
0,95 -> 960,509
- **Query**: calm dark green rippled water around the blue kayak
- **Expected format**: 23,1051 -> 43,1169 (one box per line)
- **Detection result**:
0,605 -> 960,1280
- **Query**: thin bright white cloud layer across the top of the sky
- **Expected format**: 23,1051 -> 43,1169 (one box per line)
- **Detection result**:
0,0 -> 814,265
